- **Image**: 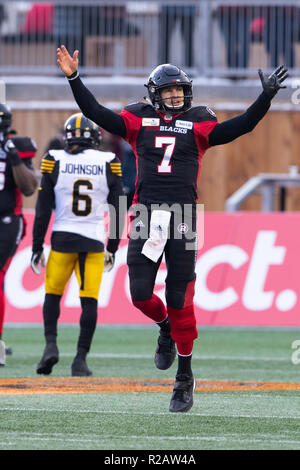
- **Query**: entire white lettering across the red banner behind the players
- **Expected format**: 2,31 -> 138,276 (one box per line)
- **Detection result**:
5,230 -> 298,312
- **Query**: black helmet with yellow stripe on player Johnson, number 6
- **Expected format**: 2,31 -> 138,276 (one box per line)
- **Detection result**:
64,113 -> 102,148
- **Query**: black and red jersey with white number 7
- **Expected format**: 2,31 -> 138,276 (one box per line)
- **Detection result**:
120,102 -> 217,204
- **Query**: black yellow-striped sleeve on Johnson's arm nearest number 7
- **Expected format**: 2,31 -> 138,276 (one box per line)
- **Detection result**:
106,157 -> 127,253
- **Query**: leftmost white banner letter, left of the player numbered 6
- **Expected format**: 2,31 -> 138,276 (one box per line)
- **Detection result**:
5,246 -> 50,309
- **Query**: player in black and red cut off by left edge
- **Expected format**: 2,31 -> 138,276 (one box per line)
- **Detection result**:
0,104 -> 37,366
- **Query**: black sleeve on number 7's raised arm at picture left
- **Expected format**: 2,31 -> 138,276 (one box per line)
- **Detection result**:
69,77 -> 126,138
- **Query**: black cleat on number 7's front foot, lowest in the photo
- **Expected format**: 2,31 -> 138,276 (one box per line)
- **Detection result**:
169,374 -> 196,413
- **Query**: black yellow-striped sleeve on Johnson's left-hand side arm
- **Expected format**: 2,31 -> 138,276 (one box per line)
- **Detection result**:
32,156 -> 58,252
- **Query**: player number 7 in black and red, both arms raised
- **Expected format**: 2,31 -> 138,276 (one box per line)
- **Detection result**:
57,46 -> 288,412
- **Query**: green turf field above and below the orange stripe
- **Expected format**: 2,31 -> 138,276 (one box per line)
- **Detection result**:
0,326 -> 300,453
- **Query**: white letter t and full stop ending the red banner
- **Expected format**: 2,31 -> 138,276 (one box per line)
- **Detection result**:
242,230 -> 296,310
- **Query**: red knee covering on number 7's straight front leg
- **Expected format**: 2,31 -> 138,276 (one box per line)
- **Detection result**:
167,305 -> 198,344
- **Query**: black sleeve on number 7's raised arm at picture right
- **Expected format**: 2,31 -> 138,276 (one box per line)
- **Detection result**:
209,92 -> 271,146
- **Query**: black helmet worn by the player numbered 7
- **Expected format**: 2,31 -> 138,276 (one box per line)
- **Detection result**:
145,64 -> 193,114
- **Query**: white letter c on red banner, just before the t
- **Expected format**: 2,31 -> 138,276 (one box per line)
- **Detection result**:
195,245 -> 248,311
